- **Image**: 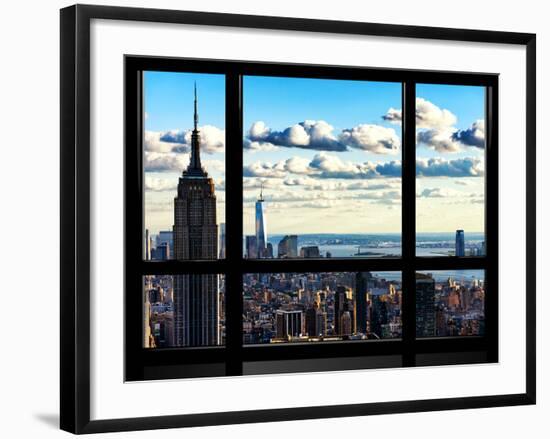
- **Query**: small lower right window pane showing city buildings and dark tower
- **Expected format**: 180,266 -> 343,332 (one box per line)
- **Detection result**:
416,270 -> 485,337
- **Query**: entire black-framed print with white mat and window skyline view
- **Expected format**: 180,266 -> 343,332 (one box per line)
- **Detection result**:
61,5 -> 536,433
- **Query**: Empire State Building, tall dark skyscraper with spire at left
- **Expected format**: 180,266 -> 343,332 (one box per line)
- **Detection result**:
173,85 -> 220,346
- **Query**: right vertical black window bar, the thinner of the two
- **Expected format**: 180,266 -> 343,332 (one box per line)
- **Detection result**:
401,81 -> 416,366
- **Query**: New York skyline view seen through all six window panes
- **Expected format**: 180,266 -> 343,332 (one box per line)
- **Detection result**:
143,72 -> 492,348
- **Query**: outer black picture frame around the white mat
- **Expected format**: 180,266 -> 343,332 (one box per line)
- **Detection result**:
60,5 -> 536,434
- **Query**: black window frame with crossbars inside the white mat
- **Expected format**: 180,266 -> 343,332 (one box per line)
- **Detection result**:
124,55 -> 498,381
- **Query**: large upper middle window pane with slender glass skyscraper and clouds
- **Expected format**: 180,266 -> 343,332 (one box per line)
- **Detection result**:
243,76 -> 402,258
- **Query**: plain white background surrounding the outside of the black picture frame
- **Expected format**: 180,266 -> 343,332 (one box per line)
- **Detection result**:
0,0 -> 550,438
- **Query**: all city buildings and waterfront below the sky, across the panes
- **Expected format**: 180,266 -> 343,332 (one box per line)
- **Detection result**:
143,84 -> 485,348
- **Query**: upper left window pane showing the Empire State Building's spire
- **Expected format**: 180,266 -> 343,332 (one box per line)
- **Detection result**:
143,71 -> 229,260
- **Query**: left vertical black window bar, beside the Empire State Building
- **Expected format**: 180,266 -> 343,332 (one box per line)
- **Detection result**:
225,69 -> 243,375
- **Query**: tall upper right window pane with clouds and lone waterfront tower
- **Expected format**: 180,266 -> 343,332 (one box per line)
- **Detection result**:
416,84 -> 485,256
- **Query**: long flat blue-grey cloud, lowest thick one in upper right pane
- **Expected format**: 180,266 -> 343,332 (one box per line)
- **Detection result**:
416,157 -> 485,177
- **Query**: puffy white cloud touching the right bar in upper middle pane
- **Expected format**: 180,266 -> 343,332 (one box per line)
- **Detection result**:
339,124 -> 401,154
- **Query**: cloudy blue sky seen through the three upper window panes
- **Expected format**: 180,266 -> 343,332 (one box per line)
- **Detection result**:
145,72 -> 484,234
